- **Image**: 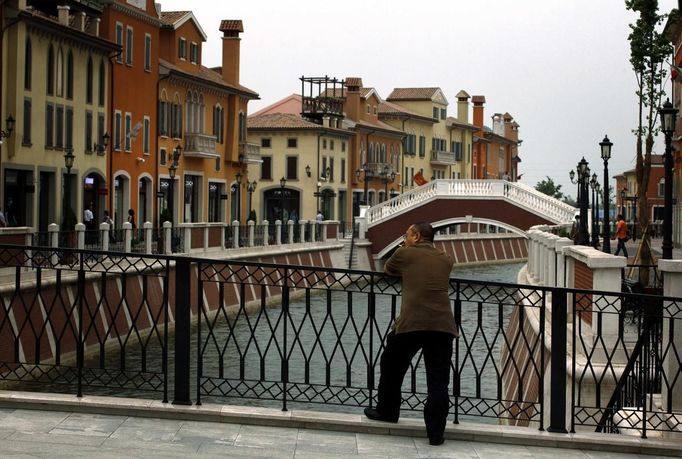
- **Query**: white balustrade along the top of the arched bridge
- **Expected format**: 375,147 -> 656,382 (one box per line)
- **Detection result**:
366,180 -> 576,227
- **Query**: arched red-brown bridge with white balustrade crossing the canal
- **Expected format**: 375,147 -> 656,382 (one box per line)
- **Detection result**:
365,180 -> 576,258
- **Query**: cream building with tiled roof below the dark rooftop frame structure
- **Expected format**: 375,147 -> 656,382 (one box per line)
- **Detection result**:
247,99 -> 354,222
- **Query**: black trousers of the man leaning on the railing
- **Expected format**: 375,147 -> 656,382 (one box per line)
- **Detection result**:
376,331 -> 454,439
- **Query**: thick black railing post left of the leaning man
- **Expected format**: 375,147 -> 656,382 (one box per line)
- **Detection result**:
173,257 -> 192,405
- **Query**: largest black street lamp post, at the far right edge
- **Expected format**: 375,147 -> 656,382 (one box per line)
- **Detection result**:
658,99 -> 678,260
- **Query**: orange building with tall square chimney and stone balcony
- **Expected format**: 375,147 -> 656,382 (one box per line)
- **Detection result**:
158,16 -> 260,226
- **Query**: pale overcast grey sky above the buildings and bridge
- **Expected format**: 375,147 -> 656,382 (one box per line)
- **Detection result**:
161,0 -> 677,197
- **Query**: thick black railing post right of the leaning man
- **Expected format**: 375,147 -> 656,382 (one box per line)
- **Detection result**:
540,288 -> 573,433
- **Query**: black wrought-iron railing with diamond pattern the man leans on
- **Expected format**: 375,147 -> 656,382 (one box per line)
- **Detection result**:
0,245 -> 682,436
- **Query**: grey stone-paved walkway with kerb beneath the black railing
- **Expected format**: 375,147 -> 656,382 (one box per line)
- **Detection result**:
0,391 -> 682,459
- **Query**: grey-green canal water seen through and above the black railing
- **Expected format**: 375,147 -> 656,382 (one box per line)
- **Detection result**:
21,263 -> 523,422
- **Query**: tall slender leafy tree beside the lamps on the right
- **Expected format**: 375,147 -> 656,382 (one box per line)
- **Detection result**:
625,0 -> 672,276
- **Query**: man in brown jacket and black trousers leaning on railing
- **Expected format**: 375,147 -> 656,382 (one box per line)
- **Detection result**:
365,222 -> 458,446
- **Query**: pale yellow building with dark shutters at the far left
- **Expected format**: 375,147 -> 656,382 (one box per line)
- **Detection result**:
0,0 -> 118,231
